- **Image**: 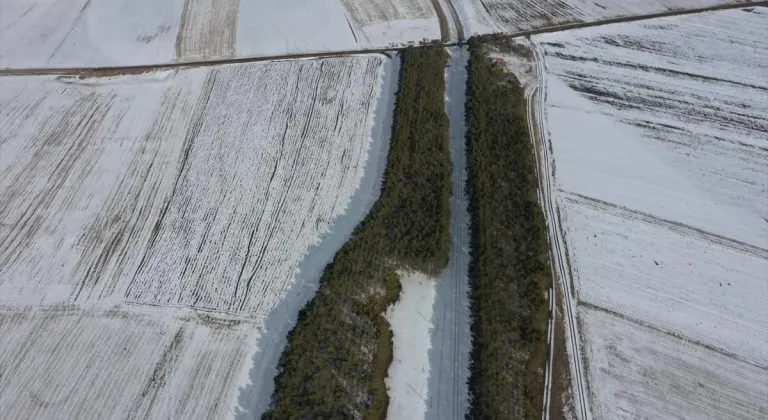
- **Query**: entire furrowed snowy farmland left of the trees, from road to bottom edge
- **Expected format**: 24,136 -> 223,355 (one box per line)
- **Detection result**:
0,55 -> 388,418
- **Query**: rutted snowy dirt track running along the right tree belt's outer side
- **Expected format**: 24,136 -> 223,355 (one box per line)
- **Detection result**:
525,42 -> 592,420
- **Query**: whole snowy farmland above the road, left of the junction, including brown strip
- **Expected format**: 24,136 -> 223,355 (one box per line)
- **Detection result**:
0,0 -> 440,68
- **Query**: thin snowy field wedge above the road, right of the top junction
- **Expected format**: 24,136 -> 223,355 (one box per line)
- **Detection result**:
454,0 -> 745,36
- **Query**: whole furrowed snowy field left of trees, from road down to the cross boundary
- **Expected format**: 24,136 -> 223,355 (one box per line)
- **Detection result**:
0,57 -> 382,319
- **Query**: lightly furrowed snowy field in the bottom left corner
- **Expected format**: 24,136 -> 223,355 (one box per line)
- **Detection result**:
0,306 -> 258,419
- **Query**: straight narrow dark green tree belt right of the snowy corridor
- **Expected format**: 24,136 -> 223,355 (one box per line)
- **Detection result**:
466,39 -> 551,420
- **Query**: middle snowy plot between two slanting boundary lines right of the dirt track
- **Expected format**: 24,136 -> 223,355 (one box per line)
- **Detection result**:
560,194 -> 768,367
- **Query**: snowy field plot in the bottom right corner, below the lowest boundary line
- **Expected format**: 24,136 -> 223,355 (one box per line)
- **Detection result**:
581,309 -> 768,420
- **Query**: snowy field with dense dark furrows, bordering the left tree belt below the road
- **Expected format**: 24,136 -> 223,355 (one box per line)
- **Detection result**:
126,59 -> 381,317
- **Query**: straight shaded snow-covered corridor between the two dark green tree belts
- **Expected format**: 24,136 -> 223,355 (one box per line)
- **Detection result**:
426,47 -> 471,420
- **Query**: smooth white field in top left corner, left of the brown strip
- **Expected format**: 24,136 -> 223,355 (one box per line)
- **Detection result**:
0,0 -> 184,68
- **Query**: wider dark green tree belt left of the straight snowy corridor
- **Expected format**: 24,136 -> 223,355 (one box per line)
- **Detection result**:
262,47 -> 451,420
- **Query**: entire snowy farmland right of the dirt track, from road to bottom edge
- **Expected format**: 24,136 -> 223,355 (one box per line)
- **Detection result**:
534,8 -> 768,419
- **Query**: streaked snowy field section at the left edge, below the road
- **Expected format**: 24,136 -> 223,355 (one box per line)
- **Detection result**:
0,72 -> 207,303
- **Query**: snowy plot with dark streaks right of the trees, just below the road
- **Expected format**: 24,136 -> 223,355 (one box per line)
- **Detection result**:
535,8 -> 768,249
